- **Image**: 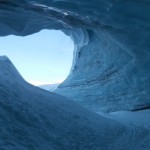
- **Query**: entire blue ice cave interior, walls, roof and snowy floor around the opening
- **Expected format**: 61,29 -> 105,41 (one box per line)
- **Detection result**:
0,0 -> 150,150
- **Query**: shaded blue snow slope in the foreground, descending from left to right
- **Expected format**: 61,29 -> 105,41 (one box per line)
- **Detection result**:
0,56 -> 150,150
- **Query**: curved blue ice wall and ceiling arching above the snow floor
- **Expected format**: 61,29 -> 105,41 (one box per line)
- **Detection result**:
0,0 -> 150,111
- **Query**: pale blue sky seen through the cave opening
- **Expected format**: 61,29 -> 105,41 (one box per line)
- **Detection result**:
0,30 -> 74,85
